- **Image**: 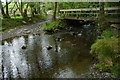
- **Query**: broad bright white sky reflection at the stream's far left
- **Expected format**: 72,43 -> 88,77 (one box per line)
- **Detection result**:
2,37 -> 28,78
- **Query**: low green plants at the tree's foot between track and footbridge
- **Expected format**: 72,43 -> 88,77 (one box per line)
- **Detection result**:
42,20 -> 67,31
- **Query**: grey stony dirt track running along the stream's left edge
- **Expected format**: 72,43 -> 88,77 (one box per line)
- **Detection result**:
0,16 -> 51,40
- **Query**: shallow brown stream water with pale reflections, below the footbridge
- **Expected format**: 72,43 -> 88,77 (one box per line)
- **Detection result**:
0,20 -> 97,78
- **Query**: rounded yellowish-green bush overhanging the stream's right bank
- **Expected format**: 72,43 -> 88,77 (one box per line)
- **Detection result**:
91,37 -> 120,62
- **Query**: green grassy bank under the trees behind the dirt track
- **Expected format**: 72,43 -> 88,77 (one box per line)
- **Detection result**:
0,15 -> 46,31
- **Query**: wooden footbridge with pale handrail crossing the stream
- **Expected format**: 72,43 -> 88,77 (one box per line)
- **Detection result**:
59,7 -> 120,23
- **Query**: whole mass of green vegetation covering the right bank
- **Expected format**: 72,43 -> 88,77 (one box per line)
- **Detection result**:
91,30 -> 120,77
